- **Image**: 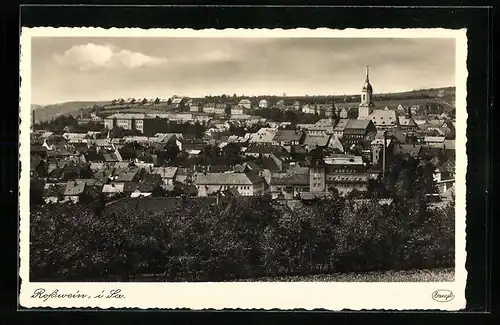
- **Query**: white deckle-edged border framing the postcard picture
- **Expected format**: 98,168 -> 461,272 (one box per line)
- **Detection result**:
19,27 -> 468,310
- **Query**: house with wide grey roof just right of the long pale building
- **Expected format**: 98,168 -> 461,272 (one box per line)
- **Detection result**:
269,169 -> 309,200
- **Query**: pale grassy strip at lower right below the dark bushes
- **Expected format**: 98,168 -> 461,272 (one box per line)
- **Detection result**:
237,268 -> 455,282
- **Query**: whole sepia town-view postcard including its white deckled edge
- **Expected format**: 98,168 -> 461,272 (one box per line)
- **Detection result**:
20,28 -> 467,309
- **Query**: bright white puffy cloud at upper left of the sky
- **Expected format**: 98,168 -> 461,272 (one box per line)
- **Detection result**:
54,43 -> 165,71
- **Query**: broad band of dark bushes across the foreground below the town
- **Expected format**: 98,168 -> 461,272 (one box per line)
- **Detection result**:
30,192 -> 454,281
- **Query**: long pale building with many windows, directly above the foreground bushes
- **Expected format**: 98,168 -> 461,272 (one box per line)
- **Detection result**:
193,172 -> 265,196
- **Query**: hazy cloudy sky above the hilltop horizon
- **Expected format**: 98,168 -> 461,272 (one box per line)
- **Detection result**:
31,37 -> 455,105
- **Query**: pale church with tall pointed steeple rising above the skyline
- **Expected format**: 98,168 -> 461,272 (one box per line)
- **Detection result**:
358,66 -> 398,130
